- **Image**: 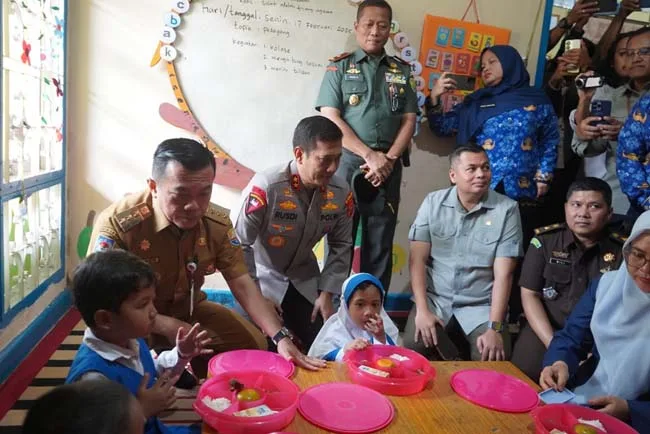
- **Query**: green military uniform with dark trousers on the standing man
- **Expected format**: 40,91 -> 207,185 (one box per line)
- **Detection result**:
316,49 -> 417,289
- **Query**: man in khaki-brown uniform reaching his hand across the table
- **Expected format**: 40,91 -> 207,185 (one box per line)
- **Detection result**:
90,139 -> 320,377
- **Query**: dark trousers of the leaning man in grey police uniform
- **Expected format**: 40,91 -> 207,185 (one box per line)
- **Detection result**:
282,283 -> 323,353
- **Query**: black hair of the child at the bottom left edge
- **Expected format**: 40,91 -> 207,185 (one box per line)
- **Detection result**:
21,379 -> 135,434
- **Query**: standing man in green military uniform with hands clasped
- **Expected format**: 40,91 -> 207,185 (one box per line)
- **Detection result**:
316,0 -> 417,290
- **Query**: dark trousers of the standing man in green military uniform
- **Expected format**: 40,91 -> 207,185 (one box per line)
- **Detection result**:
336,149 -> 402,291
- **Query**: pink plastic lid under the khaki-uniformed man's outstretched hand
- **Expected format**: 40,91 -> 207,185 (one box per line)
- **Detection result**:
208,350 -> 296,378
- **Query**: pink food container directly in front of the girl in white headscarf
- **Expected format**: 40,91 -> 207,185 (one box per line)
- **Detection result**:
343,345 -> 436,396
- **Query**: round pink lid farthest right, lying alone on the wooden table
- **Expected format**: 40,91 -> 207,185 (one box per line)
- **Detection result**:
451,369 -> 539,413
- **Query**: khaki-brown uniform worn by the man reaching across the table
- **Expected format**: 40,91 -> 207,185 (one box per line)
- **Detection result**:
90,190 -> 266,376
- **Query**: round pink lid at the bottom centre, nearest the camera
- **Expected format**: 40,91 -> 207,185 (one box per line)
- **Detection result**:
298,383 -> 395,434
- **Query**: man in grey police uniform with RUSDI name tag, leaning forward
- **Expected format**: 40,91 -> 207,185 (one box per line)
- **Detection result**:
235,116 -> 354,350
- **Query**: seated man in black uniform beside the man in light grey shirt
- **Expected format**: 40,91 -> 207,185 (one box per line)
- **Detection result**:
512,178 -> 625,381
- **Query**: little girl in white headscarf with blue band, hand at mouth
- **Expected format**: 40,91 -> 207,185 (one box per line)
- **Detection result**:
309,273 -> 399,362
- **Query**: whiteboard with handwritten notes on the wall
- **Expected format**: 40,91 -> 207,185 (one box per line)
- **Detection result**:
175,0 -> 370,171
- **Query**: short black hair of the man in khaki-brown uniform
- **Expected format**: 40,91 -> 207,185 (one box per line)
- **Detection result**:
151,138 -> 217,181
